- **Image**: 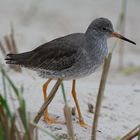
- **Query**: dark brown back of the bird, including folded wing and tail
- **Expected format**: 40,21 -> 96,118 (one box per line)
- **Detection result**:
6,33 -> 88,78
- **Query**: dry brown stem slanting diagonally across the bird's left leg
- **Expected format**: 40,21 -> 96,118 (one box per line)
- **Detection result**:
34,79 -> 62,123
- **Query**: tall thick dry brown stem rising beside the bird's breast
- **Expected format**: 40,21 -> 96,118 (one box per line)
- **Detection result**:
91,53 -> 112,140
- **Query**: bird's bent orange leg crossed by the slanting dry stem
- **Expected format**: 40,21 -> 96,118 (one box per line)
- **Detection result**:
43,78 -> 56,124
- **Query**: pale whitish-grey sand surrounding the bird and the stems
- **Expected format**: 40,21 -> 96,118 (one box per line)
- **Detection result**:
0,0 -> 140,140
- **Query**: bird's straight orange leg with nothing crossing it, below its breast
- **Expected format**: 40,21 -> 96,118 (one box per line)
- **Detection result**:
72,80 -> 87,127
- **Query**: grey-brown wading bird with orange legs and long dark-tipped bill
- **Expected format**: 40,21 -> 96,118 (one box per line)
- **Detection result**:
5,17 -> 136,126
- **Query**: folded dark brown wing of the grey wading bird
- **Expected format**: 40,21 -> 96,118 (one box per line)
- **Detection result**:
28,36 -> 77,71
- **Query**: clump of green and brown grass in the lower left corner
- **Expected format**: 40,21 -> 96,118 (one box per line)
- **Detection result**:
0,65 -> 60,140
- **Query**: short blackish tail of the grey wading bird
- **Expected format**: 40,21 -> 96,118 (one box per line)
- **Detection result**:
5,52 -> 31,66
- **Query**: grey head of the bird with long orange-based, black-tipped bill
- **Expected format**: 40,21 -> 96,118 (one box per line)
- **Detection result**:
87,18 -> 136,45
